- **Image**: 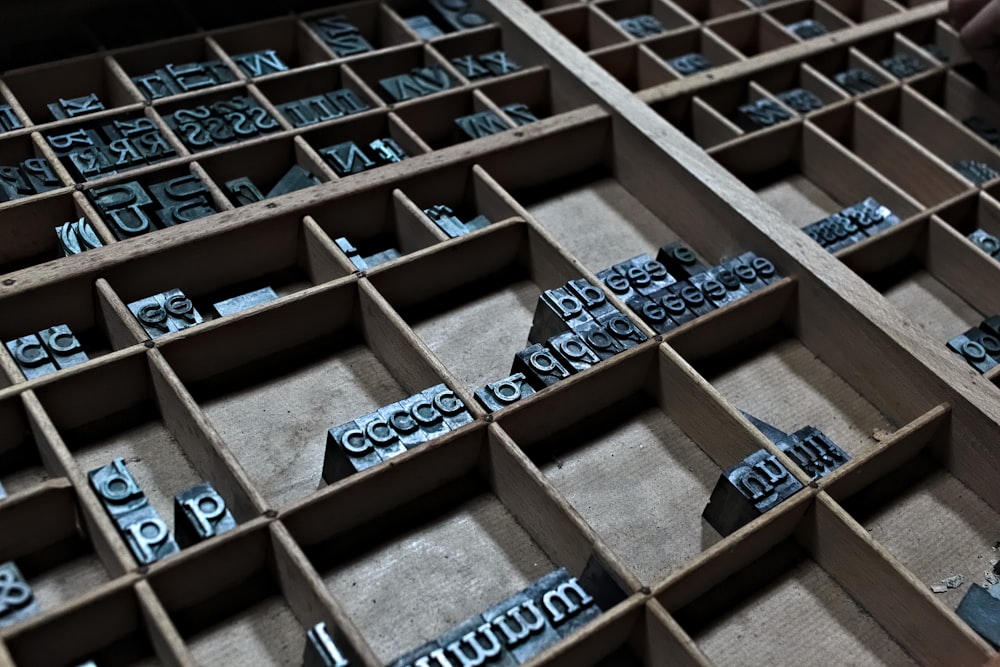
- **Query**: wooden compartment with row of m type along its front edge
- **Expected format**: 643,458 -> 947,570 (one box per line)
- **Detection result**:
285,428 -> 624,664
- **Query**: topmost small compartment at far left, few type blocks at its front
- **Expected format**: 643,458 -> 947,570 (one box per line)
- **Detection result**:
4,56 -> 141,125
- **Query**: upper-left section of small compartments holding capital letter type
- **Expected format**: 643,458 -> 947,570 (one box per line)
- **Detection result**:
0,2 -> 574,273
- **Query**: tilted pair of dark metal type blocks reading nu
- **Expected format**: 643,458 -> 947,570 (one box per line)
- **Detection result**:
702,449 -> 802,537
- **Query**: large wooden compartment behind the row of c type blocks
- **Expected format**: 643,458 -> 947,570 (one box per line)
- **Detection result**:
163,282 -> 458,508
